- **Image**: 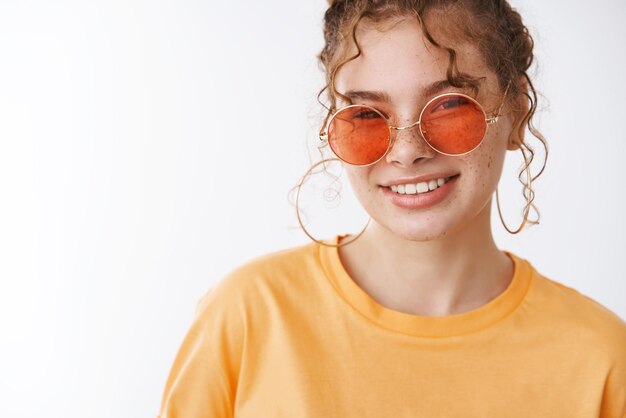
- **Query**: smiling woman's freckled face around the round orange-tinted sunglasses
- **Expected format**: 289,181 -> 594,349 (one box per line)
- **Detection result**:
335,19 -> 512,241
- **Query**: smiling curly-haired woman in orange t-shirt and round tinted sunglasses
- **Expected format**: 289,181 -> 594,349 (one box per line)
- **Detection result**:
160,0 -> 626,418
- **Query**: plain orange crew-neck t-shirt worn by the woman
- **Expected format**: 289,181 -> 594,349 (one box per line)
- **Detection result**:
159,237 -> 626,418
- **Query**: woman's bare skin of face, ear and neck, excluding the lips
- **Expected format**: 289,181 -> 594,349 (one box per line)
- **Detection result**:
335,18 -> 520,316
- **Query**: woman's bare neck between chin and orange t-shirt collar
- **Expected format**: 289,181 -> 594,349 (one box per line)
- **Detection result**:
339,204 -> 513,316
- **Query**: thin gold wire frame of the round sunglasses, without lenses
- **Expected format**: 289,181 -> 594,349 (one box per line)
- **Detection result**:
318,83 -> 510,167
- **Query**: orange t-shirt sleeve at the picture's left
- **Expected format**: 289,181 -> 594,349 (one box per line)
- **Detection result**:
157,284 -> 242,418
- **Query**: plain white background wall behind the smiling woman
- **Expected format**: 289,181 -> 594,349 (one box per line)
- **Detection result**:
0,0 -> 626,418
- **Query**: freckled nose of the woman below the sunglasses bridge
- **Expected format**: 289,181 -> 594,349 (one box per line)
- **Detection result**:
385,124 -> 437,167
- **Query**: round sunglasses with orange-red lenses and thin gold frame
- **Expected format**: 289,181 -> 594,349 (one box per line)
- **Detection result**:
319,86 -> 509,166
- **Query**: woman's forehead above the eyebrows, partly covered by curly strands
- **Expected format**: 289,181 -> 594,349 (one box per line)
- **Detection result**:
335,18 -> 495,101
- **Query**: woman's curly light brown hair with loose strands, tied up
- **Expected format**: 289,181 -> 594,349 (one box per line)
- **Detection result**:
317,0 -> 548,229
